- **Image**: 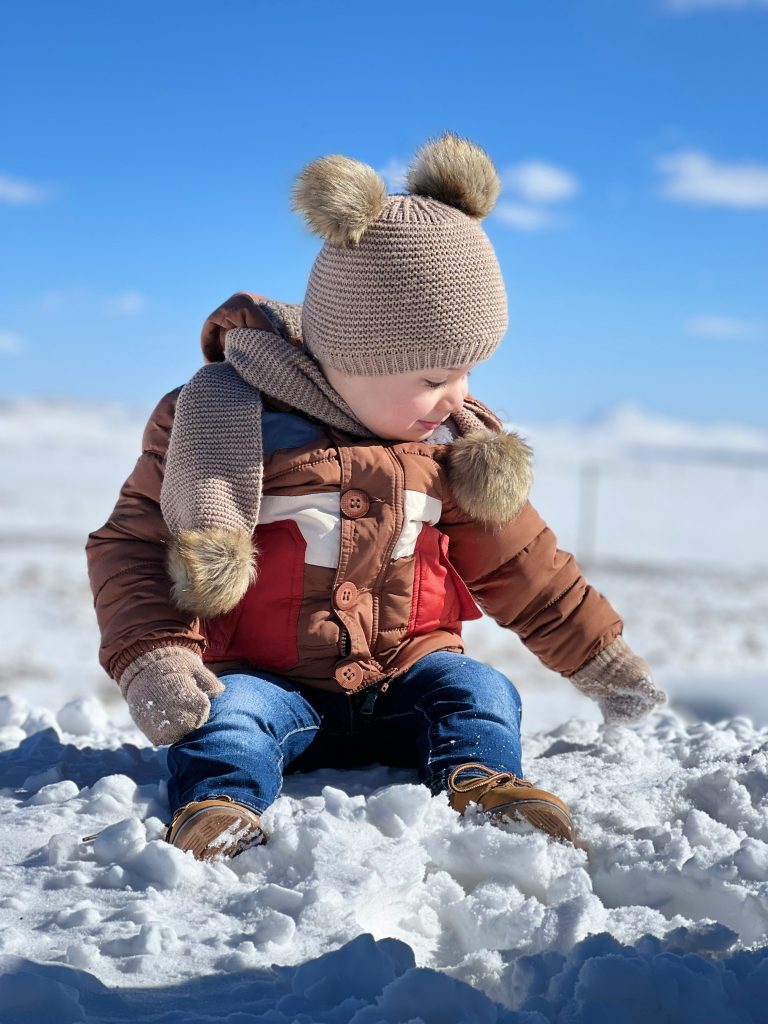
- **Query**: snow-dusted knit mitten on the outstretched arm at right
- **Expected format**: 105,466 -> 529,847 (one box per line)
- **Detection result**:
568,636 -> 667,725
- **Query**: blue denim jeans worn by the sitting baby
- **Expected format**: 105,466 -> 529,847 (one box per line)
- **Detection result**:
168,650 -> 522,814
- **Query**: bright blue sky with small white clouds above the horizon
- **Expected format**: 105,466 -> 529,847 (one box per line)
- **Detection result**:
0,0 -> 768,427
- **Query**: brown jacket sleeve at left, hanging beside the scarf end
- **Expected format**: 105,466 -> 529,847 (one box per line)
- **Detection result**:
85,387 -> 206,679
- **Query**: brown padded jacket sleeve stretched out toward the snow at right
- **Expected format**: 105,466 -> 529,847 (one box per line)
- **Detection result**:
439,502 -> 624,677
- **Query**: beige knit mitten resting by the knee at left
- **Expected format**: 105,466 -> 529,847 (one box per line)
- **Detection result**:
119,647 -> 224,746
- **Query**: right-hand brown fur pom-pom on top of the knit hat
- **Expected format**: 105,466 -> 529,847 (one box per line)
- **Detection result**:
407,132 -> 501,220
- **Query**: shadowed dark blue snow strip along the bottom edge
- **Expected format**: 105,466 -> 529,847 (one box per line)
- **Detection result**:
0,928 -> 768,1024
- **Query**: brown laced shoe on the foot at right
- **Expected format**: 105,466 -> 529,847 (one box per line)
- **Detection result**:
449,764 -> 575,843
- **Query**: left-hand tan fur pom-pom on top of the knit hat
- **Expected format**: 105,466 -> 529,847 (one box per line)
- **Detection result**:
291,154 -> 387,248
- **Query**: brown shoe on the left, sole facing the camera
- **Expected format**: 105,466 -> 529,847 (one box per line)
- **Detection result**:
165,796 -> 266,860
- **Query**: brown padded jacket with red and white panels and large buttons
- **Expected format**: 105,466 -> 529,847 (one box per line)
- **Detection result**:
86,296 -> 623,692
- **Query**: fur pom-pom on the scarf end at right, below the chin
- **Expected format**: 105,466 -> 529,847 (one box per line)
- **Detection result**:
445,430 -> 534,525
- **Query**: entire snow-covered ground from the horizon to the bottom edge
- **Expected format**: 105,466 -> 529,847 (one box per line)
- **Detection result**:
0,403 -> 768,1024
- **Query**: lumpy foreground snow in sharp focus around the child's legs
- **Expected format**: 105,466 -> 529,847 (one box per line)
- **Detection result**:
0,696 -> 768,1024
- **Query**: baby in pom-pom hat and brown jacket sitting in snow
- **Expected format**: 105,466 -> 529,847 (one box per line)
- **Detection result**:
86,132 -> 666,859
